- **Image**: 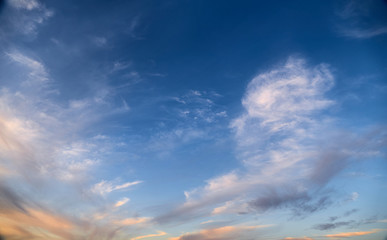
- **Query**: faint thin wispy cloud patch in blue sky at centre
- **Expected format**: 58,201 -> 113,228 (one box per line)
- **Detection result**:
144,90 -> 227,158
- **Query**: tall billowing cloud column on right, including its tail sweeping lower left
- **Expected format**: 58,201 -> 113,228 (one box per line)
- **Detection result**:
155,58 -> 333,221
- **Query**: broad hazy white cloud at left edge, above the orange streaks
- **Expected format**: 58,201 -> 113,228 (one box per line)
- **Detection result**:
0,47 -> 136,186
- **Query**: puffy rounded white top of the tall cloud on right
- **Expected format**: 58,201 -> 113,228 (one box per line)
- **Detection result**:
232,57 -> 333,134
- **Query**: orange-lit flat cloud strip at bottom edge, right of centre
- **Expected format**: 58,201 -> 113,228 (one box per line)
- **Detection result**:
169,225 -> 271,240
